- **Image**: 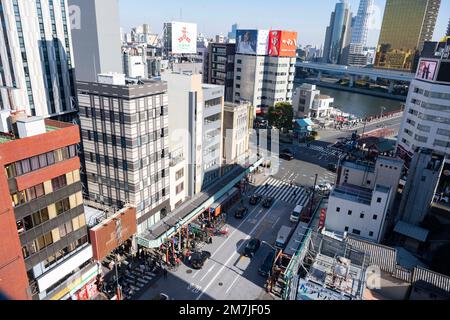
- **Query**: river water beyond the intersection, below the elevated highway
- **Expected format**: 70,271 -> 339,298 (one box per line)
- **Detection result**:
312,86 -> 402,118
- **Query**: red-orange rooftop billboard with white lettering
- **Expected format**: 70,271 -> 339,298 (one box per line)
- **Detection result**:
268,30 -> 298,57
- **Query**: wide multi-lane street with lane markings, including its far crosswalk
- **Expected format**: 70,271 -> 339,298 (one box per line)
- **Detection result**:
140,172 -> 308,300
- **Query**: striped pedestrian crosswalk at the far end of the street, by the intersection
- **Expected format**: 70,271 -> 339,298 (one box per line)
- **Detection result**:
251,177 -> 309,206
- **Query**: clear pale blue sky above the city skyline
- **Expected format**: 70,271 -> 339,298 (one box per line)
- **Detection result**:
119,0 -> 450,46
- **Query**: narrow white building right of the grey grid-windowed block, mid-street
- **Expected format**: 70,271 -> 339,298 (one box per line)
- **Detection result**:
161,72 -> 224,208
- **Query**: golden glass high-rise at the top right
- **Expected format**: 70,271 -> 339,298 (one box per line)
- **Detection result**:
375,0 -> 441,72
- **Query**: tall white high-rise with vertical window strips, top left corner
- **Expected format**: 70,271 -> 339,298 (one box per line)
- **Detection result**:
0,0 -> 76,120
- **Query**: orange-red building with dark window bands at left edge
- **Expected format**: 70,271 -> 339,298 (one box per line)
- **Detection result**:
0,114 -> 98,300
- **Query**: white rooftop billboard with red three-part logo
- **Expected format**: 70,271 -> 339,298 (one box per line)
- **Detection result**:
172,22 -> 197,54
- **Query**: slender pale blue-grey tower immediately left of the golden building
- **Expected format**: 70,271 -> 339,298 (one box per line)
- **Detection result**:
347,0 -> 373,66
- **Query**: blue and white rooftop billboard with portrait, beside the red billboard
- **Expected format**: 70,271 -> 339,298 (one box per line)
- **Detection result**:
236,30 -> 269,55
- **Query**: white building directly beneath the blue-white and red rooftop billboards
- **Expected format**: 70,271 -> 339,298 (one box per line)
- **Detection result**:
234,54 -> 296,110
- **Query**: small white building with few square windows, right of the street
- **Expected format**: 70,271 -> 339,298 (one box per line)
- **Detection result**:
325,184 -> 393,242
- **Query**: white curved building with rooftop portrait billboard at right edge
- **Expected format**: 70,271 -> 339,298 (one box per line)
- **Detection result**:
397,43 -> 450,164
